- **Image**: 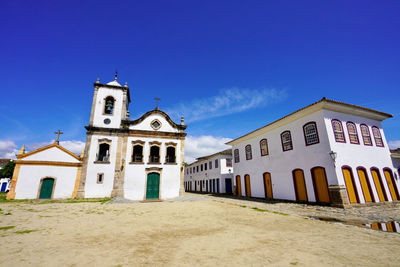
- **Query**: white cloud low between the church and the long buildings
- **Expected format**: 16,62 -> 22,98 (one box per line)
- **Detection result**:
185,135 -> 232,163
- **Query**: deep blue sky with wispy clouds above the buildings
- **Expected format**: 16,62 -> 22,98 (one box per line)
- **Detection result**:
0,0 -> 400,161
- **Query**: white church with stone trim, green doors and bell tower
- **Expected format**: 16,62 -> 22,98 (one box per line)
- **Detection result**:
7,75 -> 186,200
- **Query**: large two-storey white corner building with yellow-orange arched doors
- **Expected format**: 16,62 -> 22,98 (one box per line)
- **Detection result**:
227,98 -> 399,206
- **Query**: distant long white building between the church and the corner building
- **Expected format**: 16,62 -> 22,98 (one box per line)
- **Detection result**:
185,149 -> 233,193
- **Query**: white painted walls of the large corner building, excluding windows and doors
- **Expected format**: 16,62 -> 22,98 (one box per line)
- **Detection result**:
227,99 -> 400,204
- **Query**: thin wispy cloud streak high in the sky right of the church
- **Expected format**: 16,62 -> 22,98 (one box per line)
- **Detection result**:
166,88 -> 287,122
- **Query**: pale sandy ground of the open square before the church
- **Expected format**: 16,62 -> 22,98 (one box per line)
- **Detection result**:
0,199 -> 400,266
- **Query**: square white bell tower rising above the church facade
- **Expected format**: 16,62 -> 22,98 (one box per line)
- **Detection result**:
89,72 -> 131,129
